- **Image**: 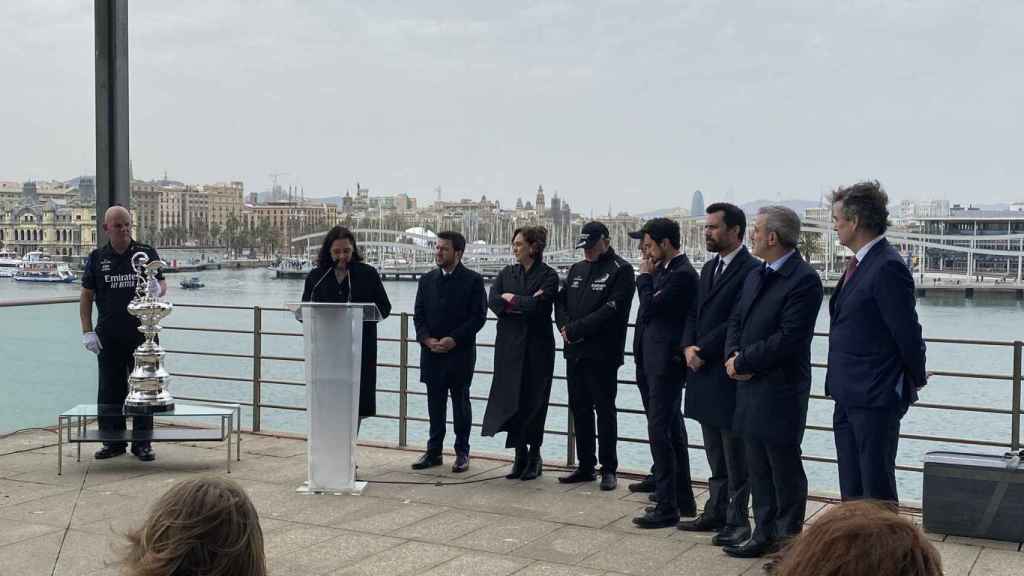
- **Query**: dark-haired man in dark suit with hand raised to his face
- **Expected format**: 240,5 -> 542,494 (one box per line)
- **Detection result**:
631,218 -> 698,528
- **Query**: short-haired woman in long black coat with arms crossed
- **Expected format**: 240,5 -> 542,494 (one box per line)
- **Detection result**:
483,227 -> 558,480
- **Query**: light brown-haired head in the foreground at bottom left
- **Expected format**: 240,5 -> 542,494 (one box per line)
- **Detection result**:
123,478 -> 266,576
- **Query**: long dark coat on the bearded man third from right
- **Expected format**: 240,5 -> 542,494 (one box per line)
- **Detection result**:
683,246 -> 760,429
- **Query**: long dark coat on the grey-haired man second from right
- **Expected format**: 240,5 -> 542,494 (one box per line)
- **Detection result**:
725,252 -> 824,446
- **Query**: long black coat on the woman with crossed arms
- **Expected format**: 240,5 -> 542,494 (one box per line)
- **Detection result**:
482,261 -> 558,439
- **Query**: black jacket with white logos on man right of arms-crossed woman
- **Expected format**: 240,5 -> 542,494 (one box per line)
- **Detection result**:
555,248 -> 634,366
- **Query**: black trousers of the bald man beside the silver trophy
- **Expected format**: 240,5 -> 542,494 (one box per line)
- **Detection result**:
96,338 -> 153,448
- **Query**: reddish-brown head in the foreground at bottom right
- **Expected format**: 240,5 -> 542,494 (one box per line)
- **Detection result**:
774,500 -> 942,576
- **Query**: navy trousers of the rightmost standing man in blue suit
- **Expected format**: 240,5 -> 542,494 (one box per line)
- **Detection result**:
833,403 -> 901,502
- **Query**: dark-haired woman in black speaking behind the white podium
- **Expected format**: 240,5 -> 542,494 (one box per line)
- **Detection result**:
302,225 -> 391,419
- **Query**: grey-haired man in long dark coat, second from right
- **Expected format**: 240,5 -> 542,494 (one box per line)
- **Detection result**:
723,206 -> 823,558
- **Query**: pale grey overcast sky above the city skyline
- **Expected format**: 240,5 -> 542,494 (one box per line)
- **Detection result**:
0,0 -> 1024,213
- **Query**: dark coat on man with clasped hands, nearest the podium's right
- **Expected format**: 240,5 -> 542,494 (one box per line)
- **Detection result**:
413,263 -> 487,385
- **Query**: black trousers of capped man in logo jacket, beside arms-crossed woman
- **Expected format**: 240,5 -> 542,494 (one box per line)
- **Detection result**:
565,359 -> 618,472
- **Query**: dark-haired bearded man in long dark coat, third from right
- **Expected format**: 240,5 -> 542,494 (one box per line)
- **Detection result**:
679,203 -> 760,546
